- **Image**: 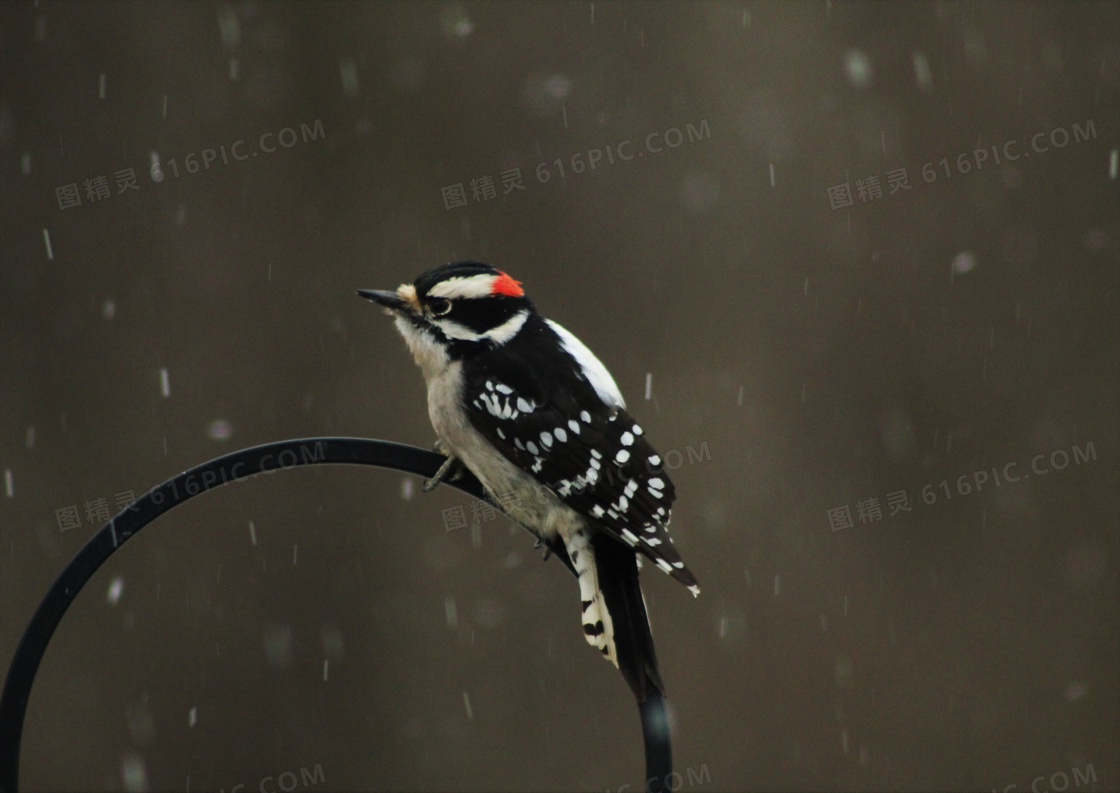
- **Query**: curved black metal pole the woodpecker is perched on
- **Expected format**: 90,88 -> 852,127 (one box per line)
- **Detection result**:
0,438 -> 672,793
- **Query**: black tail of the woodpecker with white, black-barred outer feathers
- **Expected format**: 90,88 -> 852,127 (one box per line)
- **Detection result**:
567,532 -> 665,702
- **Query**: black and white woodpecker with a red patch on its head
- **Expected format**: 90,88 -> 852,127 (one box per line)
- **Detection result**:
358,261 -> 700,701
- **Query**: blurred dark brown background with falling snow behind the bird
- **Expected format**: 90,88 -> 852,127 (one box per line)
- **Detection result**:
0,0 -> 1120,791
